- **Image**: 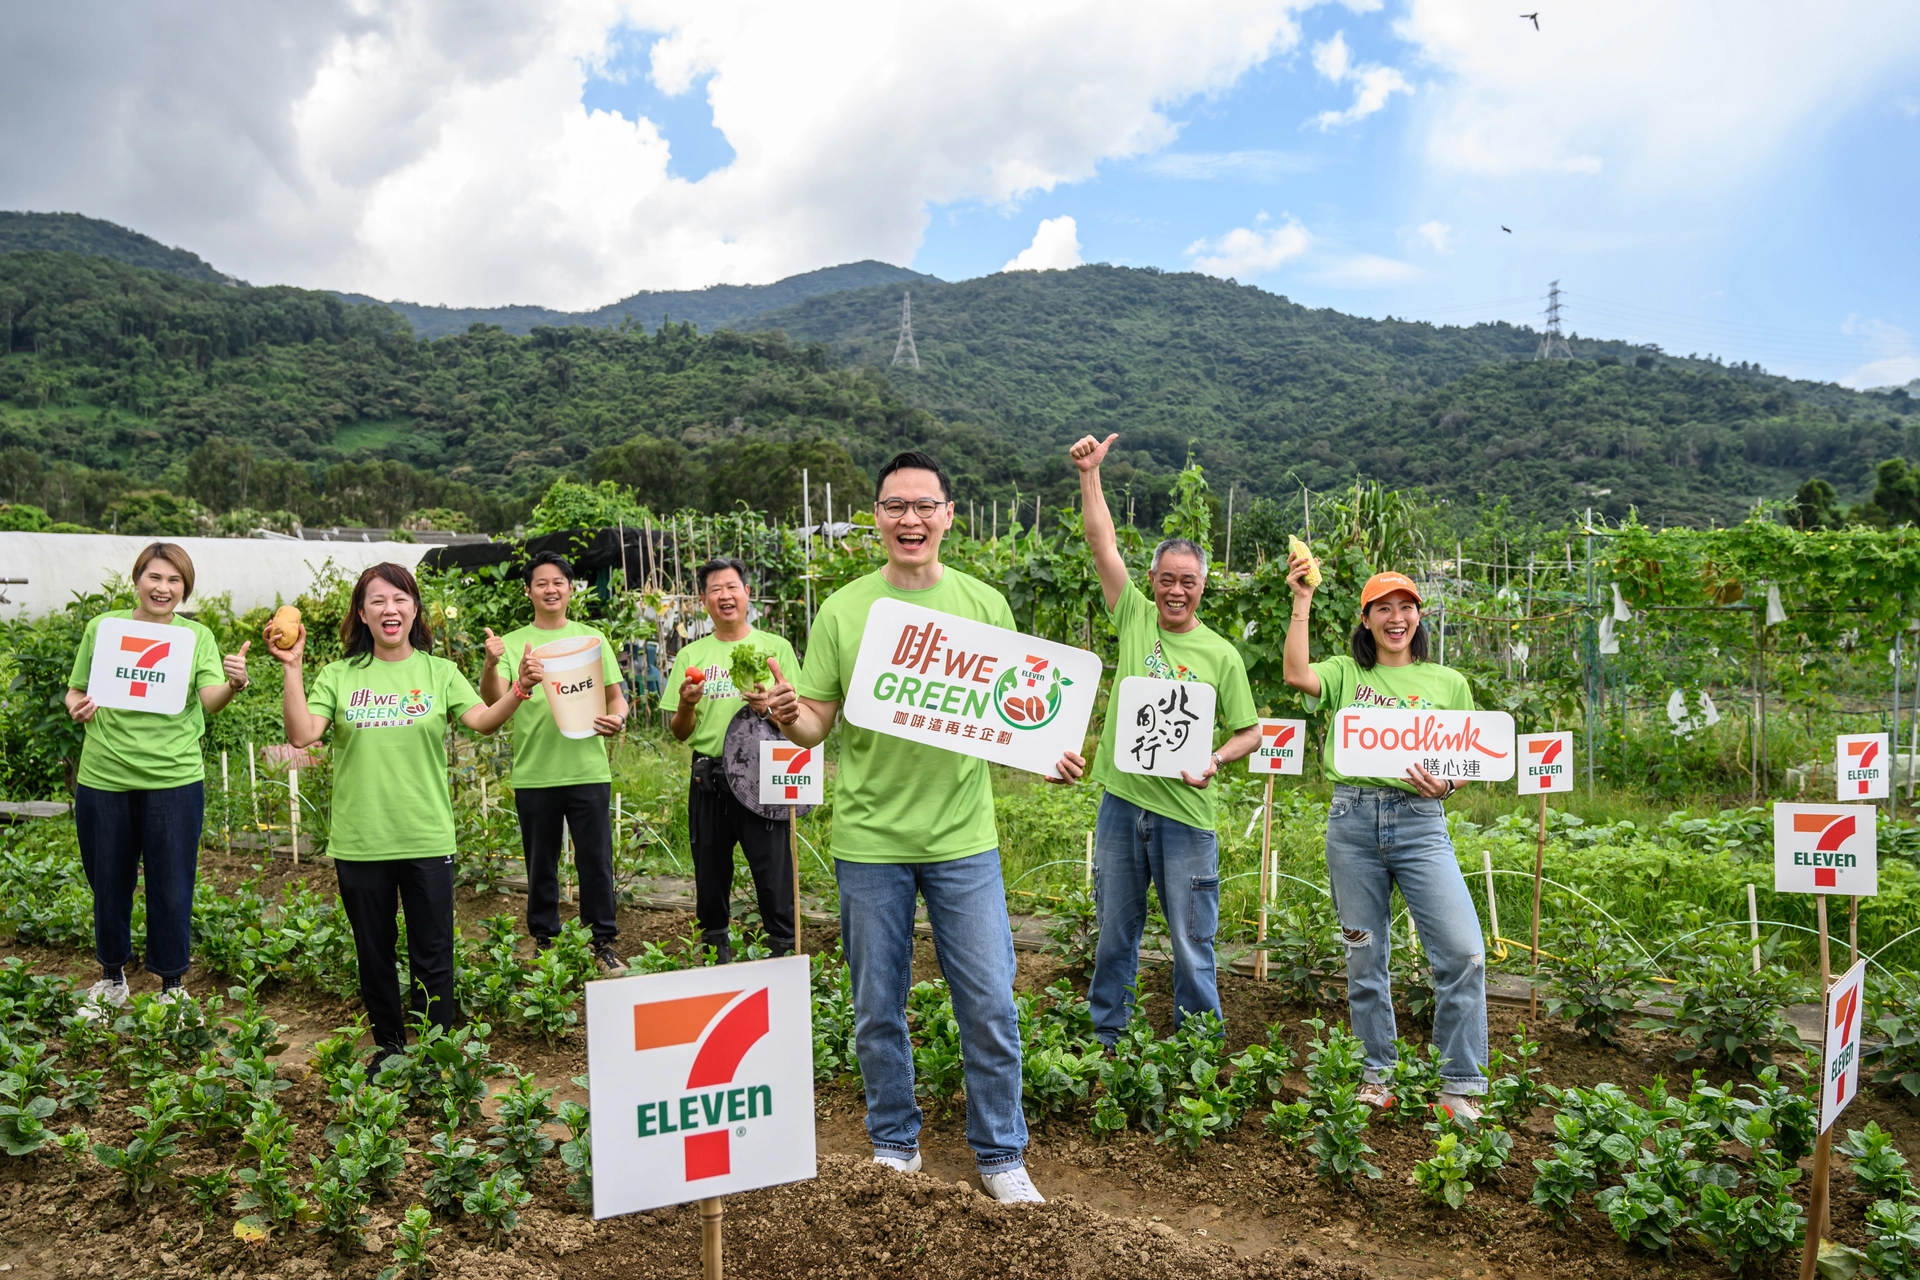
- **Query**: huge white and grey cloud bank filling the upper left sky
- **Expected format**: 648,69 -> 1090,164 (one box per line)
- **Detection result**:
0,0 -> 1308,307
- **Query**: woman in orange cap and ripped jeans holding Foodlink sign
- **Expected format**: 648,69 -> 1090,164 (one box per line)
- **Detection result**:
1283,553 -> 1486,1125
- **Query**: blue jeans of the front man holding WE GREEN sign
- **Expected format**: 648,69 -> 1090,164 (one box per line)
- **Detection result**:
833,848 -> 1027,1174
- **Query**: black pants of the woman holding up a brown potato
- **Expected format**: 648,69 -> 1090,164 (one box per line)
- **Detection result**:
334,854 -> 461,1054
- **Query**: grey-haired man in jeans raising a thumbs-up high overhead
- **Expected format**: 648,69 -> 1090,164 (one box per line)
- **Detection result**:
1069,436 -> 1260,1044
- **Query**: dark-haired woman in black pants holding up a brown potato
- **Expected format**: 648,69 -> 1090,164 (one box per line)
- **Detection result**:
267,564 -> 541,1054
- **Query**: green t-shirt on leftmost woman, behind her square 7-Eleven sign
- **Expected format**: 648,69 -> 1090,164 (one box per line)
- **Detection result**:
67,608 -> 227,791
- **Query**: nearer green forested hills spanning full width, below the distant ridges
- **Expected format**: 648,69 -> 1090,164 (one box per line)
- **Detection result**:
0,241 -> 1920,528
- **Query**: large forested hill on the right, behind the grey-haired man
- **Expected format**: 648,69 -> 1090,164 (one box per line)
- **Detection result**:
755,267 -> 1920,524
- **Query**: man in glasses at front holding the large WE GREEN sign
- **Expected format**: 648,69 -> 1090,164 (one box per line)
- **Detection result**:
766,451 -> 1085,1203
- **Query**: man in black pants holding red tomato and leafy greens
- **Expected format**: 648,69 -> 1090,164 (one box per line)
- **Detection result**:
666,558 -> 801,963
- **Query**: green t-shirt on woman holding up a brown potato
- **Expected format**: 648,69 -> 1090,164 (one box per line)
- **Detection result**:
307,649 -> 480,862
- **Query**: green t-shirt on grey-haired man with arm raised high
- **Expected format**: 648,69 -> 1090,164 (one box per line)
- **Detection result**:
1092,583 -> 1260,831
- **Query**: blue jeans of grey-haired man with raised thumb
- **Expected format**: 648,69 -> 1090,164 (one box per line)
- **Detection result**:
1087,793 -> 1219,1044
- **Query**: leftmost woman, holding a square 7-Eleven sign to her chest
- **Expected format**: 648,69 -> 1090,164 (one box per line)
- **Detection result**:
67,543 -> 252,1019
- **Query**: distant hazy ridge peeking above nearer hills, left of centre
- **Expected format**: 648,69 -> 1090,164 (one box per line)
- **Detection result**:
340,259 -> 933,338
